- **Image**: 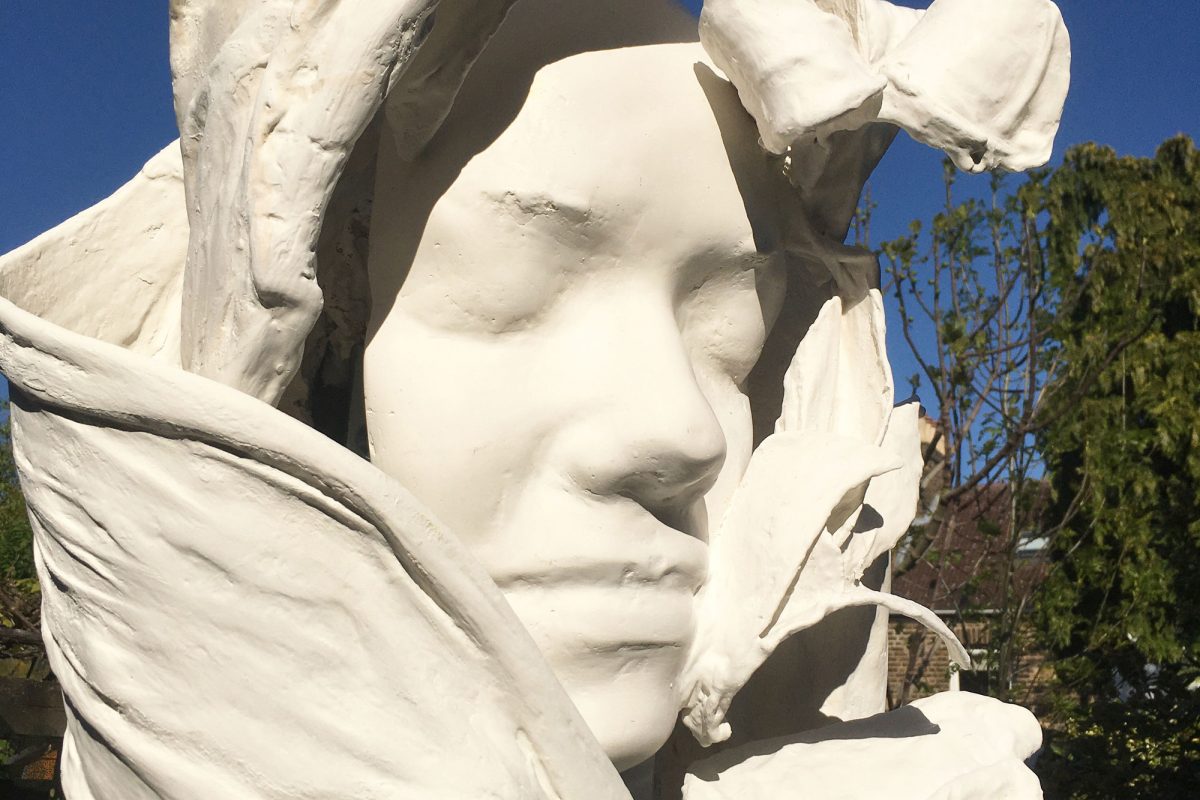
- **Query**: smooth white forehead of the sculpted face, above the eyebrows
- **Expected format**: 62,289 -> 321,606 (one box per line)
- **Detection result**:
431,44 -> 775,249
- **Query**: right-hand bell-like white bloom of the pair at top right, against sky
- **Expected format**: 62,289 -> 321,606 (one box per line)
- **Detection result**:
880,0 -> 1070,172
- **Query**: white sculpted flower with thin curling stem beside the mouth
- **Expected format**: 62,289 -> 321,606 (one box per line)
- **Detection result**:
682,289 -> 970,746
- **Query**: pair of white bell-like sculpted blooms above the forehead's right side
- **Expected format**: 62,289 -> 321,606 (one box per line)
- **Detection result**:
700,0 -> 1070,172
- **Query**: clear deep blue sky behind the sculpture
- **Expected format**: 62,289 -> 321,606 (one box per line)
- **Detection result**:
0,0 -> 1200,407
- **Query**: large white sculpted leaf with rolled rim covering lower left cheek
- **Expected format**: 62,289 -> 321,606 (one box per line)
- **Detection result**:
0,301 -> 629,800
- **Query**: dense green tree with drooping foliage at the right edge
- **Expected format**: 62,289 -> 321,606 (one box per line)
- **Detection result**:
1039,137 -> 1200,700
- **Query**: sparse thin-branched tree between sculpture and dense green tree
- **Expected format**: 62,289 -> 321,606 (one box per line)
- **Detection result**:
873,162 -> 1058,702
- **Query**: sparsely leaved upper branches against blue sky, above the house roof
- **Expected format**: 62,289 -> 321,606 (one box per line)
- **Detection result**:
881,161 -> 1052,495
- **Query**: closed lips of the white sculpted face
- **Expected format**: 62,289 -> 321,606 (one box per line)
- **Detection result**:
479,493 -> 708,670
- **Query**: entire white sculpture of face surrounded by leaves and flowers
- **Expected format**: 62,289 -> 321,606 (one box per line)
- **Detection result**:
0,0 -> 1068,800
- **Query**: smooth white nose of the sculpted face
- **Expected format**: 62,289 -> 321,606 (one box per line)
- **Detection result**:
556,287 -> 726,528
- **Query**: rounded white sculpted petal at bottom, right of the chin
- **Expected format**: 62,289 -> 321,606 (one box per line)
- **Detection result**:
684,692 -> 1042,800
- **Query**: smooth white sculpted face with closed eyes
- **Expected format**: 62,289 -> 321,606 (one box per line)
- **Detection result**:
365,46 -> 784,768
